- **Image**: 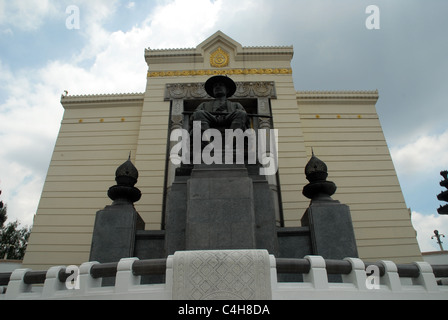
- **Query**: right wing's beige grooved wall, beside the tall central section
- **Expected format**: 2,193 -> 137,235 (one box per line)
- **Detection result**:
297,92 -> 422,263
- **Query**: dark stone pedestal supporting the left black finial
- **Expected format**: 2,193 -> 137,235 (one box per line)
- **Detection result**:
90,200 -> 145,263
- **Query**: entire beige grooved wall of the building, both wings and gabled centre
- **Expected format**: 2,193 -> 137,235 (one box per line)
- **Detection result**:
24,32 -> 421,269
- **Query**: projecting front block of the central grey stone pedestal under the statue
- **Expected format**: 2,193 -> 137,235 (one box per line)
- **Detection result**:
185,165 -> 256,250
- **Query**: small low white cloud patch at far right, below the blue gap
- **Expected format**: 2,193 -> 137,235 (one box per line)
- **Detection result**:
412,211 -> 448,252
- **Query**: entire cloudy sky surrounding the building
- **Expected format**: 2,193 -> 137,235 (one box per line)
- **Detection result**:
0,0 -> 448,251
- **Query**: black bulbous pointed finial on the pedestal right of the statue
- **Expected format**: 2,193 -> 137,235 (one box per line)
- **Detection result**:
302,150 -> 337,201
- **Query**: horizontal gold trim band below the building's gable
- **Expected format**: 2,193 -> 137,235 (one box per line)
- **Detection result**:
148,68 -> 292,78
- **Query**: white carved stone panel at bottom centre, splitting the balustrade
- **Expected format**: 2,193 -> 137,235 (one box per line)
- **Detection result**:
173,250 -> 272,300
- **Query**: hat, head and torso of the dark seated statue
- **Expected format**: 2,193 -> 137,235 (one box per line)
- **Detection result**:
191,76 -> 249,132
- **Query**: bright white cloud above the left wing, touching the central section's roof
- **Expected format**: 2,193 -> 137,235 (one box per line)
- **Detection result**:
60,0 -> 222,94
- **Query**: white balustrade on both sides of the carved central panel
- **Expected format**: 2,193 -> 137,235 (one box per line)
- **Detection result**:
0,251 -> 448,301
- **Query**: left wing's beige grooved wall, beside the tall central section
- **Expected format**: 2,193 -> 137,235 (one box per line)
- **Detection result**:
23,94 -> 143,269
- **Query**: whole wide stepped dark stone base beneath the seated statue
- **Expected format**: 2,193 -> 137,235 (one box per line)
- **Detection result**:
165,159 -> 278,255
